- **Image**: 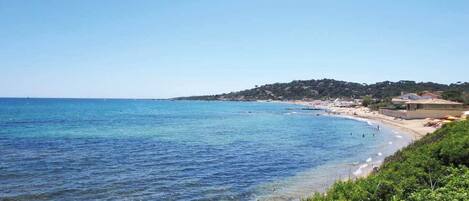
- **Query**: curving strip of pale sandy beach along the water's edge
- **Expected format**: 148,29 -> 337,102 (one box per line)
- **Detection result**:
254,101 -> 436,200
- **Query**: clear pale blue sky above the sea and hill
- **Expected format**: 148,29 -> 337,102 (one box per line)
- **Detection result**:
0,0 -> 469,98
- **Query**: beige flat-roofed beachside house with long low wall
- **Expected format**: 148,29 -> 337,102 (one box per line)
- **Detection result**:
379,99 -> 464,119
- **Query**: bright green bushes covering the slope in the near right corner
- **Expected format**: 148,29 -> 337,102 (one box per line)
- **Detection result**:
307,121 -> 469,201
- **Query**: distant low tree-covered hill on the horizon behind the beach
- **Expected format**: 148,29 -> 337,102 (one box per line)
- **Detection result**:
174,79 -> 469,101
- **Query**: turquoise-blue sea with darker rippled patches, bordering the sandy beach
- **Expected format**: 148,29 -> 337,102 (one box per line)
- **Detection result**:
0,99 -> 408,200
